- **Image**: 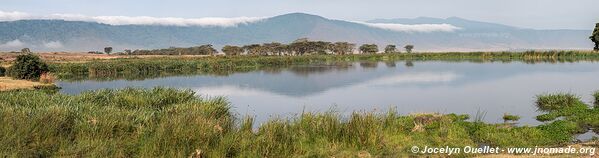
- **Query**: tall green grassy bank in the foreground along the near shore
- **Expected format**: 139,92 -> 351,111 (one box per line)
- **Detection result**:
0,88 -> 599,157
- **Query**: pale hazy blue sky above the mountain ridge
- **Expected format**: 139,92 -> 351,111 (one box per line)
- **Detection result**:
0,0 -> 599,30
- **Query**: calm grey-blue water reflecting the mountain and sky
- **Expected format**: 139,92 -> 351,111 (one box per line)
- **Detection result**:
58,61 -> 599,125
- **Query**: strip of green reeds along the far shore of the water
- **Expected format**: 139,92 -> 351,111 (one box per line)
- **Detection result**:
51,51 -> 599,80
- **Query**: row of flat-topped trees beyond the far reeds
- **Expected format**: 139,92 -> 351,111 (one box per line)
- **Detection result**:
121,38 -> 414,56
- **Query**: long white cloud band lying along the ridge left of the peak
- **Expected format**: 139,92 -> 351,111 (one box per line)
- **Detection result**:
0,11 -> 264,27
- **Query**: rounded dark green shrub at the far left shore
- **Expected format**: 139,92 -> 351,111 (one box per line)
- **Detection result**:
8,54 -> 49,80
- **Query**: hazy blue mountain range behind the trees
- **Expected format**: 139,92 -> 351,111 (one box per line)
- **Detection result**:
0,13 -> 592,51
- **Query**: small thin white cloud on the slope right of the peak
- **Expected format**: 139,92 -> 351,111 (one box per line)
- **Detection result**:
357,22 -> 462,33
